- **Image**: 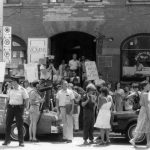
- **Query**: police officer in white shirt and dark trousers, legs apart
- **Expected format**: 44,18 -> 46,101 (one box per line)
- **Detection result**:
3,77 -> 29,147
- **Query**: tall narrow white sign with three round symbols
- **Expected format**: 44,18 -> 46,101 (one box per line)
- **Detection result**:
3,26 -> 11,64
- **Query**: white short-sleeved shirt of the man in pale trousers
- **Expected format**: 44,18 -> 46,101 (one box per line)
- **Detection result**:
56,89 -> 75,106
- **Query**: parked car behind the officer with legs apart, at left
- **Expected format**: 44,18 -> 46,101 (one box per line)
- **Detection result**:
0,94 -> 62,140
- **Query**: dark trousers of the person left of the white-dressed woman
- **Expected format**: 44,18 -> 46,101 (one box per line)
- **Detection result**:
83,110 -> 94,141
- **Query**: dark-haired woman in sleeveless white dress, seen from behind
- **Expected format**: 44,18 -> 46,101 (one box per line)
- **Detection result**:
94,87 -> 112,144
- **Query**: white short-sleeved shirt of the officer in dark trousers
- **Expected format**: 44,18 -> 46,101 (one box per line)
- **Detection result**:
8,86 -> 29,105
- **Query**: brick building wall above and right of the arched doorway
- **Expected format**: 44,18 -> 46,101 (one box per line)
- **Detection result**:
4,0 -> 150,81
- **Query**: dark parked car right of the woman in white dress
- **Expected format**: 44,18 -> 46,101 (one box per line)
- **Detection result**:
112,110 -> 145,143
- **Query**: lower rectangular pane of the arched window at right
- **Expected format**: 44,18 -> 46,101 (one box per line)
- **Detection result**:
122,50 -> 150,80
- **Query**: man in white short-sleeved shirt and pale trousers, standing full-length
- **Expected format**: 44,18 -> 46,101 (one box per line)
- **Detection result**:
56,81 -> 75,143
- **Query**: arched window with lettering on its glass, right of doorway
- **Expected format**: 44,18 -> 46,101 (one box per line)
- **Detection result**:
121,33 -> 150,81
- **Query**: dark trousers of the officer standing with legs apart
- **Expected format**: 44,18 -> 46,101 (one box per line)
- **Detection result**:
5,105 -> 24,143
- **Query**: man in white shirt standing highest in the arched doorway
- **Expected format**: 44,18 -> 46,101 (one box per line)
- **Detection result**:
69,54 -> 80,71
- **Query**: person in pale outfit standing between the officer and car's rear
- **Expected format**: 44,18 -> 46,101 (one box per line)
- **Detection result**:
29,82 -> 44,142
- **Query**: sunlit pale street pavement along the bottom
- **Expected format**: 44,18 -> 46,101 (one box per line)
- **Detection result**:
0,133 -> 146,150
